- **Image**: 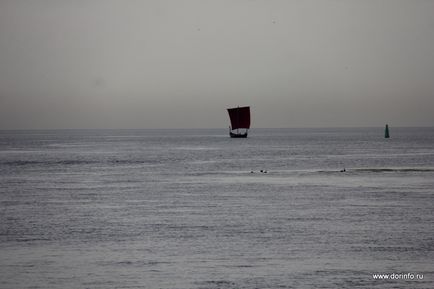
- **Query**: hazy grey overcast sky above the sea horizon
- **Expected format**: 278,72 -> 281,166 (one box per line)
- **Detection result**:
0,0 -> 434,129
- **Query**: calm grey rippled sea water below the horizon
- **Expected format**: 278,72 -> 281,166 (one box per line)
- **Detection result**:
0,128 -> 434,289
